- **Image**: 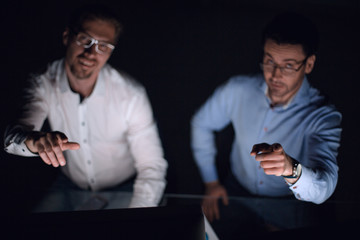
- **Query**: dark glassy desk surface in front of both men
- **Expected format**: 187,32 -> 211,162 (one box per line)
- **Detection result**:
6,191 -> 360,240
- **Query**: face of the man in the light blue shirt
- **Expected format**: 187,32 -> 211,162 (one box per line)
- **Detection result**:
263,40 -> 315,104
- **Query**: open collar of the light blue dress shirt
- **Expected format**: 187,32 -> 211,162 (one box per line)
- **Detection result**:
261,76 -> 310,110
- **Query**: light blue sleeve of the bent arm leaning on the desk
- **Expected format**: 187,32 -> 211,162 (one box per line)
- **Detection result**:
191,79 -> 231,182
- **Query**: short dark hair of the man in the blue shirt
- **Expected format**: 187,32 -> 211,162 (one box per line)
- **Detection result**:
262,12 -> 319,57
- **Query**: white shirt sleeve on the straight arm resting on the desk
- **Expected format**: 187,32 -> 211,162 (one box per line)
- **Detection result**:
126,90 -> 168,207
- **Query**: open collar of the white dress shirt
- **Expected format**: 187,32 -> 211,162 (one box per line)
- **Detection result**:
57,60 -> 106,96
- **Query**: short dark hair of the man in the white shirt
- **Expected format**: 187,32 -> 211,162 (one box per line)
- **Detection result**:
67,4 -> 123,43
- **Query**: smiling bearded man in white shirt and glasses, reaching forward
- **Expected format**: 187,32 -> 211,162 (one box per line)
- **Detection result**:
5,6 -> 167,207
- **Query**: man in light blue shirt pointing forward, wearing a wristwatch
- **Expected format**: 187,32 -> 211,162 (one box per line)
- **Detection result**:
191,11 -> 341,220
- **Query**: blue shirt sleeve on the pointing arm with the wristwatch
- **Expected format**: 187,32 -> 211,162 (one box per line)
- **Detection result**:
289,111 -> 341,204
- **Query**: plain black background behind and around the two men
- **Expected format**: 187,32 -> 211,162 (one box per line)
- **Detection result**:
0,0 -> 360,214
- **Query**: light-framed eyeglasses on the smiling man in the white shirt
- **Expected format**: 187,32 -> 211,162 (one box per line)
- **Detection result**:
75,32 -> 115,54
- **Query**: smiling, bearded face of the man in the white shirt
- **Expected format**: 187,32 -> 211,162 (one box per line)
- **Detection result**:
63,20 -> 115,80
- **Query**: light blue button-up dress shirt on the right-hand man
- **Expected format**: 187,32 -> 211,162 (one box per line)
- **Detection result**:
191,74 -> 341,203
